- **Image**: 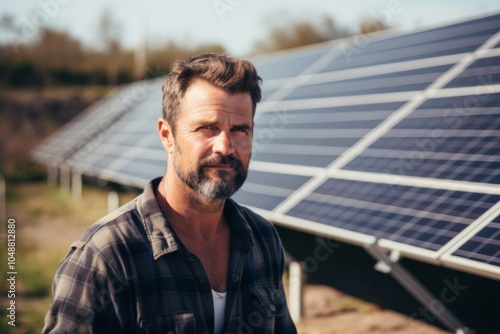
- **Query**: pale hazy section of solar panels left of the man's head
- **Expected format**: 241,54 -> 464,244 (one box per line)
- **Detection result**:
33,79 -> 166,187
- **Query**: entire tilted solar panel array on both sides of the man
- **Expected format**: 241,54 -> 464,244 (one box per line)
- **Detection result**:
34,13 -> 500,279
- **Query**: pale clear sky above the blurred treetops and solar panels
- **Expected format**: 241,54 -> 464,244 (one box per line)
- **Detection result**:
0,0 -> 500,56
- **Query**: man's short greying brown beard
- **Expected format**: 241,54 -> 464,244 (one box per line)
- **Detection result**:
173,146 -> 248,202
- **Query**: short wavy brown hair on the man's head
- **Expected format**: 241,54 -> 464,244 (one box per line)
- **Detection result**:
162,53 -> 262,131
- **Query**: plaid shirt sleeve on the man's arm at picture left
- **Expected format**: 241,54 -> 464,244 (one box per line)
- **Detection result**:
42,244 -> 129,333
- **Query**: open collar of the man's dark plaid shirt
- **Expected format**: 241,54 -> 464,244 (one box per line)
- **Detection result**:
137,177 -> 253,260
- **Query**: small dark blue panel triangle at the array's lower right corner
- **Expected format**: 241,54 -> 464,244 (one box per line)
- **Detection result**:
453,216 -> 500,266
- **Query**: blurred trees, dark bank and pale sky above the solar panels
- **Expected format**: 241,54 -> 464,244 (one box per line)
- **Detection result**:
0,0 -> 500,177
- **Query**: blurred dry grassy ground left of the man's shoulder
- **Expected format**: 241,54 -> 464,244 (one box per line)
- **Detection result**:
0,182 -> 135,334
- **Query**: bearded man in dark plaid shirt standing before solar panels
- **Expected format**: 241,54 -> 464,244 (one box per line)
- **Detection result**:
42,54 -> 296,334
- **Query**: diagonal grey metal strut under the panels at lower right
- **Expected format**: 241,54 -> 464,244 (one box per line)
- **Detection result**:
365,243 -> 473,334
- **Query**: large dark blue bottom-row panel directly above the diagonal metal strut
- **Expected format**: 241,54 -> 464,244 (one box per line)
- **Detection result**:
287,179 -> 500,250
